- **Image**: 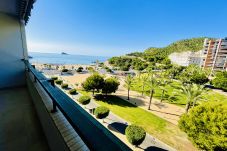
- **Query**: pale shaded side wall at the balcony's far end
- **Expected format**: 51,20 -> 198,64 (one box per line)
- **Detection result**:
0,13 -> 27,89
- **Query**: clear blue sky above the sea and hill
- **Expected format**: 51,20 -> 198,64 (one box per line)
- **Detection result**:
26,0 -> 227,56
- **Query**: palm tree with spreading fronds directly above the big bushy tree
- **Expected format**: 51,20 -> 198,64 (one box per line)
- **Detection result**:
180,84 -> 207,113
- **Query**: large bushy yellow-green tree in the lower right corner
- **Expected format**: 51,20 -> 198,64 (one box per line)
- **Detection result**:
179,102 -> 227,151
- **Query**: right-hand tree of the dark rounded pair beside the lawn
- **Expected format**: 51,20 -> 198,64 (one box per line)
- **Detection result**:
102,78 -> 120,95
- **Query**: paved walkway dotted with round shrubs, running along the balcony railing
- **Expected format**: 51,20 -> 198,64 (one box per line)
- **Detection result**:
59,82 -> 175,151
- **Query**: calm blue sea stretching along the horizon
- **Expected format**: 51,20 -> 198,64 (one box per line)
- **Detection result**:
28,52 -> 110,65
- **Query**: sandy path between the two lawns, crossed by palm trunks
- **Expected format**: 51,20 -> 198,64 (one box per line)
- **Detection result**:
115,78 -> 185,125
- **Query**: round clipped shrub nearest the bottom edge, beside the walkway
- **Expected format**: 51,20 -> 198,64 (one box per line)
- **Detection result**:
125,125 -> 146,146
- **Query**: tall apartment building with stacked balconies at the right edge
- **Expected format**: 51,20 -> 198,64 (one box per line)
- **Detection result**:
201,38 -> 227,71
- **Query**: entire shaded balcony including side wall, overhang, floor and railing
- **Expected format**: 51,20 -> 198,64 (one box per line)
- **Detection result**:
0,0 -> 131,151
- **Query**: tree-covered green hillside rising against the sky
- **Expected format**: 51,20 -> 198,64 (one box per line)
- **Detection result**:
108,37 -> 213,70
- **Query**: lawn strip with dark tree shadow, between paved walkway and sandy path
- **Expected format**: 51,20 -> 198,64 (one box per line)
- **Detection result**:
79,91 -> 195,150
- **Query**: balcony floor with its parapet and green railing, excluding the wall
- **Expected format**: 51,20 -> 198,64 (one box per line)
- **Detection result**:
0,62 -> 131,151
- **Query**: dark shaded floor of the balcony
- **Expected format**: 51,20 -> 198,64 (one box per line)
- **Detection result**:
0,88 -> 49,151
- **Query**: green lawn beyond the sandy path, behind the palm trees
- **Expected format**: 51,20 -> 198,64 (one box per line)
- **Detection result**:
132,80 -> 227,107
